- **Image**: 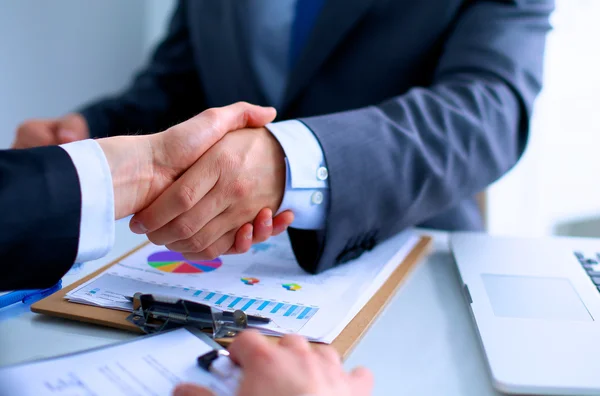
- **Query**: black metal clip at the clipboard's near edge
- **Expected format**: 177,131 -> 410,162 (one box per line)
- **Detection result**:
127,293 -> 270,339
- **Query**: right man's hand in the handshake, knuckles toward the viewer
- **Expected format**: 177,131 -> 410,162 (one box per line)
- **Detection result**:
131,125 -> 286,259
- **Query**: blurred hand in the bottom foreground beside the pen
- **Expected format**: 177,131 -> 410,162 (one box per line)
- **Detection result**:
174,331 -> 373,396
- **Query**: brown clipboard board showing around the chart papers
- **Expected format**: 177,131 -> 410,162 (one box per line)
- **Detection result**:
31,236 -> 432,359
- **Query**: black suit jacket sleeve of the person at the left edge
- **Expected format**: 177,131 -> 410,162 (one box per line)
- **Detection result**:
0,147 -> 81,290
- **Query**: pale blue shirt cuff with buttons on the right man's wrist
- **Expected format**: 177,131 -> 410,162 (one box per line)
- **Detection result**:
266,120 -> 329,230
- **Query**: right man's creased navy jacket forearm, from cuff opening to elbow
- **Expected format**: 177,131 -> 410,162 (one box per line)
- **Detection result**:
290,75 -> 527,272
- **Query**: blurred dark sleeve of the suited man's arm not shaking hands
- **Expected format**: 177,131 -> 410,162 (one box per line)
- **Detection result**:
79,1 -> 205,138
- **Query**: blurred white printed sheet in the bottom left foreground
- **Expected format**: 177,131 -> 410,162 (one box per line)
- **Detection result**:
0,329 -> 228,396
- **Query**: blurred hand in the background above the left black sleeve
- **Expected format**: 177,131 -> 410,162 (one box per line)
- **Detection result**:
12,113 -> 90,149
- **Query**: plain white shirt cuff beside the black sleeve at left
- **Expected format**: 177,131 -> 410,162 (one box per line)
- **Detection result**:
60,139 -> 115,263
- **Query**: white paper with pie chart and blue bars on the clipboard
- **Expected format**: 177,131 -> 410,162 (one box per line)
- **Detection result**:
65,231 -> 419,343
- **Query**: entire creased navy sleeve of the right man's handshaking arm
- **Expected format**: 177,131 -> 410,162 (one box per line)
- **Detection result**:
290,0 -> 553,272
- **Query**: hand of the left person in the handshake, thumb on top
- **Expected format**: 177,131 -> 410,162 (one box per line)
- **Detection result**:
98,103 -> 276,219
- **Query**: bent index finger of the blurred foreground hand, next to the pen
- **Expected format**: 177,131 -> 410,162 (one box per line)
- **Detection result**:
229,330 -> 275,369
